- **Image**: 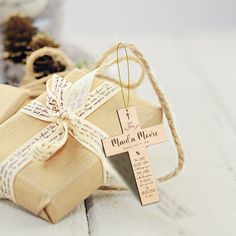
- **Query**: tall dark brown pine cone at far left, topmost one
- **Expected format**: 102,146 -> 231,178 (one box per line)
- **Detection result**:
3,16 -> 37,63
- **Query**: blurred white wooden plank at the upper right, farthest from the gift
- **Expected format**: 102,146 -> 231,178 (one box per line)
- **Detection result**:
179,30 -> 236,120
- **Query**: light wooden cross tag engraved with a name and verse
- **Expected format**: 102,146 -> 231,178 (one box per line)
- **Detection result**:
102,106 -> 166,205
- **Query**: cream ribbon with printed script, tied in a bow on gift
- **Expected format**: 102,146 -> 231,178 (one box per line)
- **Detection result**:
0,65 -> 120,202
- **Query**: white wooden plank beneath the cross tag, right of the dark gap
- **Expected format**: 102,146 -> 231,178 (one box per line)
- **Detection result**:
85,37 -> 236,236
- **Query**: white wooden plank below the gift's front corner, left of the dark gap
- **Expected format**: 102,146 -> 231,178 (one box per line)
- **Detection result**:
0,201 -> 89,236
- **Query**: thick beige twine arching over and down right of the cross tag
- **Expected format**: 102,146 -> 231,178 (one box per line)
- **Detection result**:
96,43 -> 184,182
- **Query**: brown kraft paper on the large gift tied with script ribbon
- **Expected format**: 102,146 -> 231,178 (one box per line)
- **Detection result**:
0,69 -> 162,223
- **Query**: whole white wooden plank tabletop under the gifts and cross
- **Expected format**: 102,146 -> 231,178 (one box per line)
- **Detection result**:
0,32 -> 236,236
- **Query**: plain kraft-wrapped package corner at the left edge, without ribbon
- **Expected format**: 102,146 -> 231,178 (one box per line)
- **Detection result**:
0,84 -> 29,124
